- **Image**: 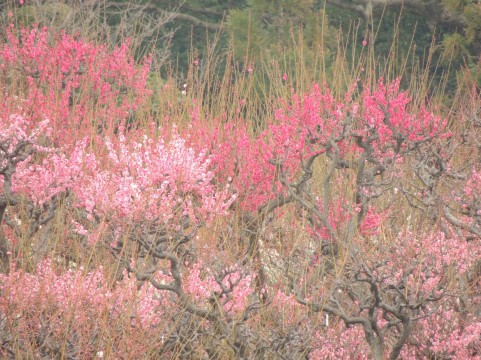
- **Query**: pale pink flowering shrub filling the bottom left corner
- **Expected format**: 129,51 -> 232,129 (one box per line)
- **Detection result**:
0,260 -> 166,358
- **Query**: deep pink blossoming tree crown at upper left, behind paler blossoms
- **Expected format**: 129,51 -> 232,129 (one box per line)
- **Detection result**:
0,27 -> 150,145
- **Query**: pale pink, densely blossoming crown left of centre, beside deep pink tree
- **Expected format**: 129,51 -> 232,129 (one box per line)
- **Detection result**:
77,129 -> 235,229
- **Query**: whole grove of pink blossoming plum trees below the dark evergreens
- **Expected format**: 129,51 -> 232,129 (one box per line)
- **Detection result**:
0,23 -> 481,359
